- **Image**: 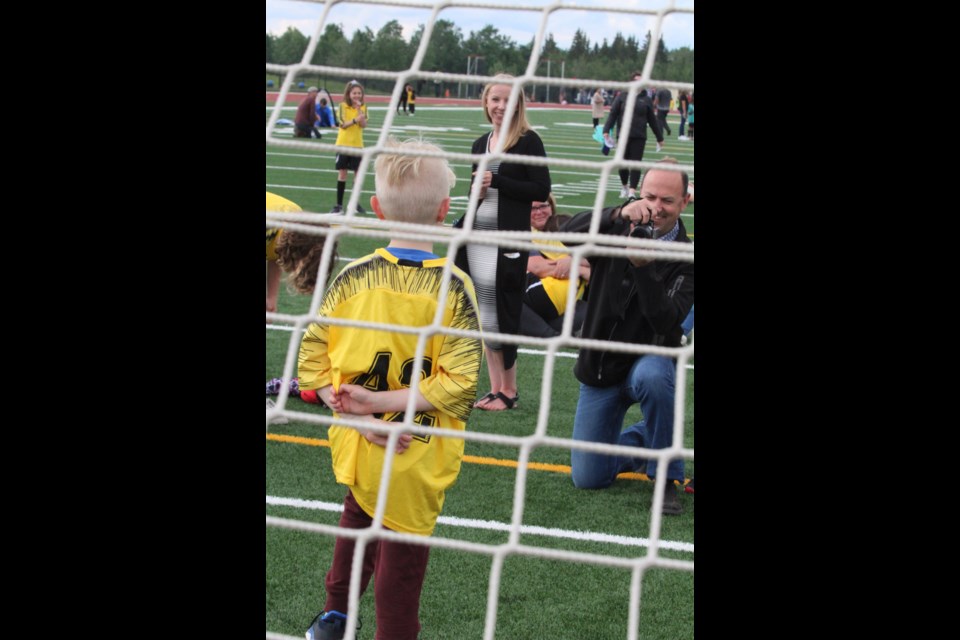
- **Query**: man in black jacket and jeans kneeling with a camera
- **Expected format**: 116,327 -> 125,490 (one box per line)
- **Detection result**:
560,159 -> 693,515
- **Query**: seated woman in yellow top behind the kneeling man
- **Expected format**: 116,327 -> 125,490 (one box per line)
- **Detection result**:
520,193 -> 590,338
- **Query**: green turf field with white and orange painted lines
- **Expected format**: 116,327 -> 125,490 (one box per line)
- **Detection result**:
265,103 -> 694,640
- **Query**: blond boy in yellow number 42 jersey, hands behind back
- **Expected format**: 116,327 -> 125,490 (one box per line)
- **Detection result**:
298,139 -> 482,640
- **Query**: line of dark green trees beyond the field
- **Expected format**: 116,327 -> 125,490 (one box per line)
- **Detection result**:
266,20 -> 693,102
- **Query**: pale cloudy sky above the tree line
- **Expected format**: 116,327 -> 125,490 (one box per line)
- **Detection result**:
266,0 -> 694,49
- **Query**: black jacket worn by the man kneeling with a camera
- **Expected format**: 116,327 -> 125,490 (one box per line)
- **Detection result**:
560,207 -> 693,387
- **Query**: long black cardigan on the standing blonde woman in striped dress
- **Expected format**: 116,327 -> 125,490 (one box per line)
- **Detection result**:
454,131 -> 551,369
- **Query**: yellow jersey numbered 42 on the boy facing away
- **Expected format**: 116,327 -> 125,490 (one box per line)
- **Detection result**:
298,249 -> 482,535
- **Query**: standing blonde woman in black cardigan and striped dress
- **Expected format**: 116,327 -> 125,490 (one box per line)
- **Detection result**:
456,74 -> 550,411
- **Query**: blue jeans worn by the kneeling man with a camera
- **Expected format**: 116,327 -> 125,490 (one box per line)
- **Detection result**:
570,355 -> 684,489
